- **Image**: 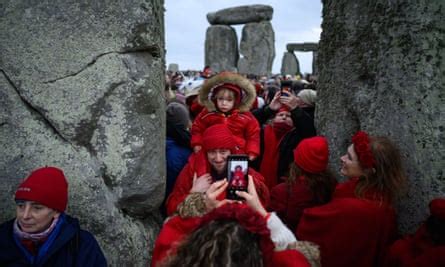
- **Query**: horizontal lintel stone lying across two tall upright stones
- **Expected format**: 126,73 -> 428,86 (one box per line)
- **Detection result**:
207,5 -> 273,25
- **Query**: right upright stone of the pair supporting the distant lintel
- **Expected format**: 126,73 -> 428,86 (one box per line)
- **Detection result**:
238,21 -> 275,75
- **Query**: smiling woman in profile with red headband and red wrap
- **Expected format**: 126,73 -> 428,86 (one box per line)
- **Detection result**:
297,131 -> 406,267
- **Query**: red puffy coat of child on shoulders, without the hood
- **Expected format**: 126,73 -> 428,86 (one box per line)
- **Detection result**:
191,109 -> 260,155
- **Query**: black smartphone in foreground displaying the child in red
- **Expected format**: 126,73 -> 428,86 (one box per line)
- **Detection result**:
226,155 -> 249,200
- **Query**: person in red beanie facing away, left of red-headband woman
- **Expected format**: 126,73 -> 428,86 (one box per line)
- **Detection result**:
269,136 -> 337,230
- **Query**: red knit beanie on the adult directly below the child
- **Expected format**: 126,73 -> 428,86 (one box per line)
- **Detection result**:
202,124 -> 236,151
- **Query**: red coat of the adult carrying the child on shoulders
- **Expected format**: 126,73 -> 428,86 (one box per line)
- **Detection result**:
166,152 -> 269,216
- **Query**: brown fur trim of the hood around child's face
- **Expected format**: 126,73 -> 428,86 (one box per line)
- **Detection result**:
198,72 -> 256,112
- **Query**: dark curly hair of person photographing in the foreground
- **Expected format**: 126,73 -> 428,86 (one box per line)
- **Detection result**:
161,220 -> 263,267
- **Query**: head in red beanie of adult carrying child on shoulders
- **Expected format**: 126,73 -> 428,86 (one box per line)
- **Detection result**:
202,124 -> 236,173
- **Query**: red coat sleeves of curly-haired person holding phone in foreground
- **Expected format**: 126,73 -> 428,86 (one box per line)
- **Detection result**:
151,216 -> 310,267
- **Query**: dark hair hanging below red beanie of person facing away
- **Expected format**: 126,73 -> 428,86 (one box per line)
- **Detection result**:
286,162 -> 337,204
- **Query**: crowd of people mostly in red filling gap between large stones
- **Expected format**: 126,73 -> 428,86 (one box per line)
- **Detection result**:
160,67 -> 445,267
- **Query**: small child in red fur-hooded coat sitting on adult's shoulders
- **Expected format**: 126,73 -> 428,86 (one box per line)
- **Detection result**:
191,72 -> 260,160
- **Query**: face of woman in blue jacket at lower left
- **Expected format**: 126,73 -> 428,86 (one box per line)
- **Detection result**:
16,200 -> 60,233
